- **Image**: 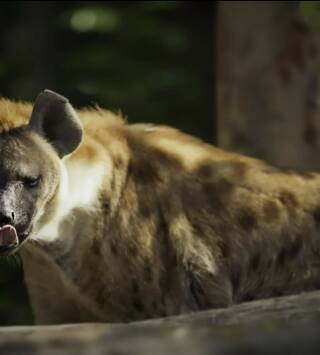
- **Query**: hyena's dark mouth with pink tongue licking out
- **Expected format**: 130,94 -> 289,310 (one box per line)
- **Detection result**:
0,224 -> 29,255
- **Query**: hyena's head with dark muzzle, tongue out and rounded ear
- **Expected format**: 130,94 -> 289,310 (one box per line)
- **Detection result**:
0,90 -> 82,254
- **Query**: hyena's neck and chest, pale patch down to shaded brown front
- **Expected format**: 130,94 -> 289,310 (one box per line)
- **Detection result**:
22,129 -> 131,323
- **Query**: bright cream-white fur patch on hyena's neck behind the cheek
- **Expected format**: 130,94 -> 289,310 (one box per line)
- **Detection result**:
34,139 -> 113,243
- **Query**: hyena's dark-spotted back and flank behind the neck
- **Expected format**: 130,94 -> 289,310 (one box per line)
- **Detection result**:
92,121 -> 320,311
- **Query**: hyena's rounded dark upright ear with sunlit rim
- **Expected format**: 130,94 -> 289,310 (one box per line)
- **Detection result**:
29,90 -> 82,158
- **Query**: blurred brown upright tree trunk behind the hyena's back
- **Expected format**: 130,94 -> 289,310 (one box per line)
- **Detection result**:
216,1 -> 320,170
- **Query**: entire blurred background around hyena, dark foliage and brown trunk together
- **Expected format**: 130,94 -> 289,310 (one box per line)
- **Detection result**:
0,1 -> 320,325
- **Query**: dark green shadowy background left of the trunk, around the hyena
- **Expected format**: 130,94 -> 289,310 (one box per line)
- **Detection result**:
0,1 -> 215,325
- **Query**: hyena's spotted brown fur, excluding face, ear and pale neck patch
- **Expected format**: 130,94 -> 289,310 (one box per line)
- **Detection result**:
0,96 -> 320,323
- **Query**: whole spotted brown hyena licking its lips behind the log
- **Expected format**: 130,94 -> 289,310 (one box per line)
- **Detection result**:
0,90 -> 320,324
